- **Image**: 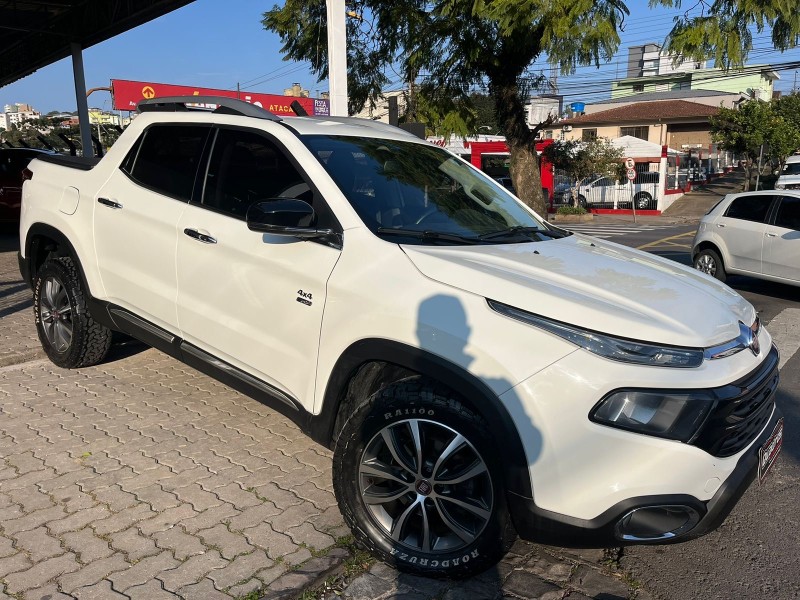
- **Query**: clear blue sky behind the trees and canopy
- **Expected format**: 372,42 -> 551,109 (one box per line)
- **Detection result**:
0,0 -> 800,113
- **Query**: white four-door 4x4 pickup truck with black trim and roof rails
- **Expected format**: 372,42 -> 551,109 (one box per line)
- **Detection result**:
19,97 -> 783,576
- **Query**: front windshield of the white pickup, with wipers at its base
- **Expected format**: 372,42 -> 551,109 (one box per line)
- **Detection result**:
302,136 -> 547,243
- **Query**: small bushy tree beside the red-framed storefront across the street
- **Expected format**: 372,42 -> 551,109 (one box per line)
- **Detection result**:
542,138 -> 624,206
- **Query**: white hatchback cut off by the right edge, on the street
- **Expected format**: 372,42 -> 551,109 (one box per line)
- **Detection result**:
692,190 -> 800,285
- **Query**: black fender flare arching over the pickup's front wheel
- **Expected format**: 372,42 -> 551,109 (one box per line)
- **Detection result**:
308,339 -> 533,498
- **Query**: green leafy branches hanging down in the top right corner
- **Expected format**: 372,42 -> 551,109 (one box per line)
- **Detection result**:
650,0 -> 800,69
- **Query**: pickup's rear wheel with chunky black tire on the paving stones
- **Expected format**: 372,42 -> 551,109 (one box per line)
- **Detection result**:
33,258 -> 111,369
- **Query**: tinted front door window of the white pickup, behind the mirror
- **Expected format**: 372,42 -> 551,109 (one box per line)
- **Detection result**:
203,129 -> 313,219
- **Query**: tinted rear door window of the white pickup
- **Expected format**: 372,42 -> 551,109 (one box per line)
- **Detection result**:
122,125 -> 211,201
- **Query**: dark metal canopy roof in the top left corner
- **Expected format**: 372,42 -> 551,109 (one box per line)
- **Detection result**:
0,0 -> 193,87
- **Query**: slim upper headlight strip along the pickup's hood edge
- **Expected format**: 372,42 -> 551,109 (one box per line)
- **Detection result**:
488,300 -> 703,368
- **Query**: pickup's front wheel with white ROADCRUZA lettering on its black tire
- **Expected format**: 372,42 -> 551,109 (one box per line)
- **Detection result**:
333,377 -> 516,578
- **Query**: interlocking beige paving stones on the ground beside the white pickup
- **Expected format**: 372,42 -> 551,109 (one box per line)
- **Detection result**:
0,237 -> 645,600
